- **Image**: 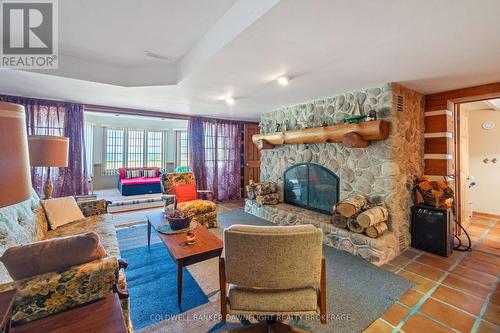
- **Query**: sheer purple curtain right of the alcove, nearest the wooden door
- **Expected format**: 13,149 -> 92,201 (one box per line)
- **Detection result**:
188,117 -> 242,201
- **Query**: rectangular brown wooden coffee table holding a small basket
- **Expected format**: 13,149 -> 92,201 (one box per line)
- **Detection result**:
146,212 -> 223,308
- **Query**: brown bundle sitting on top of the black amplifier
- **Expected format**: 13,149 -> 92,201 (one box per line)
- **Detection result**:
414,176 -> 454,208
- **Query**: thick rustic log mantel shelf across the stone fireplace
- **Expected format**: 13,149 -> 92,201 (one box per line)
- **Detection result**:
252,120 -> 389,149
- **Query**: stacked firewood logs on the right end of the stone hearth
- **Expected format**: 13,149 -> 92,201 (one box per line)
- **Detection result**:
331,194 -> 389,238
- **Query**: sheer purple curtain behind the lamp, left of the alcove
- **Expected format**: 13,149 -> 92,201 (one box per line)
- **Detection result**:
0,95 -> 88,197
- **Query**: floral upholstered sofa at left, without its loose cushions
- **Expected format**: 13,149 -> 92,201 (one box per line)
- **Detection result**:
0,192 -> 132,331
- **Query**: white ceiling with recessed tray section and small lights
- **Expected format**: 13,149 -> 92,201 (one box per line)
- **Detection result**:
0,0 -> 500,120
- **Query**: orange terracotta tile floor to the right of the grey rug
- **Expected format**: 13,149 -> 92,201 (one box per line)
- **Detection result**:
364,218 -> 500,333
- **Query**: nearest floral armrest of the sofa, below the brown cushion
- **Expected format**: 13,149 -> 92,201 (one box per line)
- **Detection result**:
0,257 -> 120,324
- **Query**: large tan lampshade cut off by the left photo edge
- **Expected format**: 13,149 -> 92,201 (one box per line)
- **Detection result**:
0,102 -> 31,207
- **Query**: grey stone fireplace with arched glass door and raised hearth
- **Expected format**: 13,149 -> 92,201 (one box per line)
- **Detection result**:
245,83 -> 424,265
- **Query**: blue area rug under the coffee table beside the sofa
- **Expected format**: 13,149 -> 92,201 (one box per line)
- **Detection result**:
117,228 -> 208,330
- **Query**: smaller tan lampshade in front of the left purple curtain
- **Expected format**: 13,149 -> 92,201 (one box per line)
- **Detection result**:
28,135 -> 69,167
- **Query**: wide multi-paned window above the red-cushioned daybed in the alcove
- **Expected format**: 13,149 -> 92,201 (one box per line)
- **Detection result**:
104,128 -> 166,173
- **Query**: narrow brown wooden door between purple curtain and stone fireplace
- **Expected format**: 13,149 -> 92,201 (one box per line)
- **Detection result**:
243,123 -> 260,198
